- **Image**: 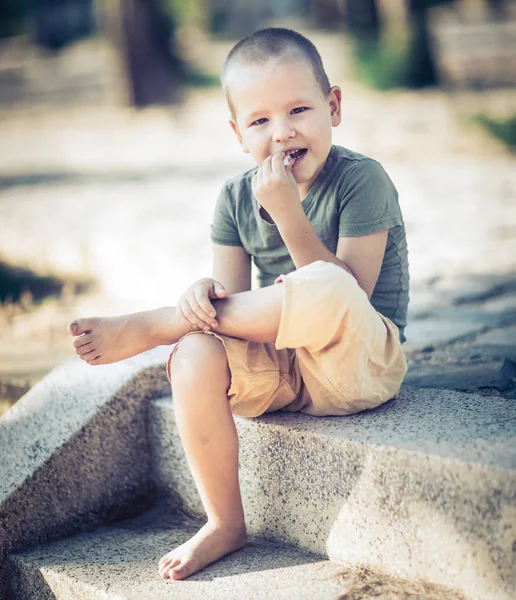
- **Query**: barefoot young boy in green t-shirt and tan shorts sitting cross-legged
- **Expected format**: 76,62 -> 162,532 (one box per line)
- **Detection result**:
70,28 -> 408,579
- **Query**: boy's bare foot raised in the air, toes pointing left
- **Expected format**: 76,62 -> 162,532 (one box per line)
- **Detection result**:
68,312 -> 160,365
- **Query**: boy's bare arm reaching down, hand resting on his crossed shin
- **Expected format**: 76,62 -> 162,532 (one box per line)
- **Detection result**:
178,244 -> 251,331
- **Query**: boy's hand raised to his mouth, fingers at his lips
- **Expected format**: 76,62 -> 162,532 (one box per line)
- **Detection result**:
251,150 -> 301,221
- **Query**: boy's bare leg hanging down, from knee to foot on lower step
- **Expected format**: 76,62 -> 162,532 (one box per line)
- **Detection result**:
158,334 -> 247,579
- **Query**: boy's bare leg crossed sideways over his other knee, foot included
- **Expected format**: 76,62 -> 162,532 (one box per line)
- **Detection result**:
70,284 -> 283,365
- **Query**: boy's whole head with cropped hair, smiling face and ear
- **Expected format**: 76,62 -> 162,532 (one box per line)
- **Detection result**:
221,28 -> 341,193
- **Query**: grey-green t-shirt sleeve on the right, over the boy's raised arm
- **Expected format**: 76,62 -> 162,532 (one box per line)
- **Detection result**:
339,159 -> 403,237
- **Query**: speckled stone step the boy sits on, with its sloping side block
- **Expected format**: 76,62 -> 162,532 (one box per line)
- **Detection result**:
0,349 -> 516,600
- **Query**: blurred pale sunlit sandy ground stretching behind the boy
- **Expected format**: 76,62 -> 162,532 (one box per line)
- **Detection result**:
0,33 -> 516,412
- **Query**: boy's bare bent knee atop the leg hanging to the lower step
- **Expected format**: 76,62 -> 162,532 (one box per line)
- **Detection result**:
170,332 -> 229,383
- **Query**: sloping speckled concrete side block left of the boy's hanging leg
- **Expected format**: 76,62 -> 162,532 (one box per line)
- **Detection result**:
0,352 -> 173,590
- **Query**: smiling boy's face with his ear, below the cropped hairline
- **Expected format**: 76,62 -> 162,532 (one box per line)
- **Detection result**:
230,58 -> 341,198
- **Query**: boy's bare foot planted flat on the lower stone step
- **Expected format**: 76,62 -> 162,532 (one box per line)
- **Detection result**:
159,522 -> 247,579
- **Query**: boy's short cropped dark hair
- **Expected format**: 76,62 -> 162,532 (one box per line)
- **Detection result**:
220,27 -> 331,117
